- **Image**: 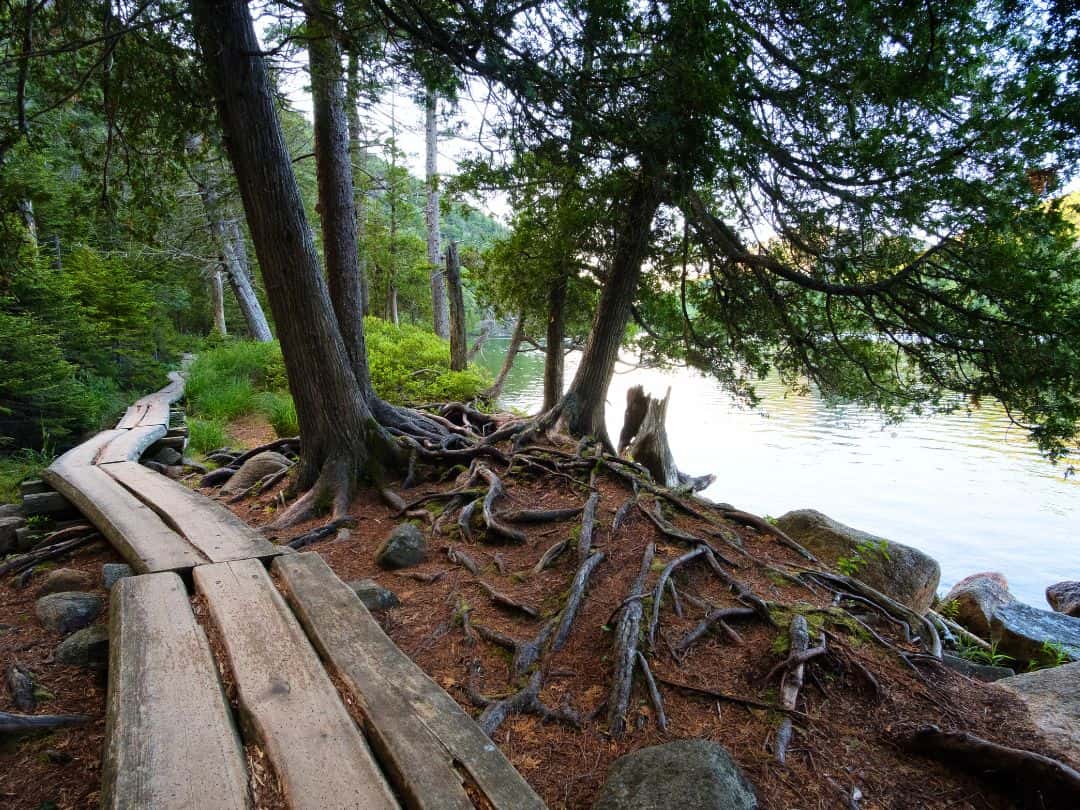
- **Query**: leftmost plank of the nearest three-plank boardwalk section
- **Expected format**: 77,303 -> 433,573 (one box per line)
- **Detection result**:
102,573 -> 251,810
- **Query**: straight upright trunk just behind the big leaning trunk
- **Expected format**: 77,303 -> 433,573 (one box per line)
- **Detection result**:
303,0 -> 374,402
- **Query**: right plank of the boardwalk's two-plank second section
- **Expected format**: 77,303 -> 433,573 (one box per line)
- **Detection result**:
102,461 -> 284,563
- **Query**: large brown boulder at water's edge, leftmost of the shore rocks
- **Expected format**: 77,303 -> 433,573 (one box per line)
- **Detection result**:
777,509 -> 941,615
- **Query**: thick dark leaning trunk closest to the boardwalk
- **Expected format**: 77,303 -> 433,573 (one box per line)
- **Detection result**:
191,0 -> 391,511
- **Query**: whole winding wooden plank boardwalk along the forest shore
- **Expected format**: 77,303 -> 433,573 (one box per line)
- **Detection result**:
43,374 -> 544,810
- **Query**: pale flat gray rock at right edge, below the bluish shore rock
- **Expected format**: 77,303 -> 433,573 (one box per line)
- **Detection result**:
997,663 -> 1080,766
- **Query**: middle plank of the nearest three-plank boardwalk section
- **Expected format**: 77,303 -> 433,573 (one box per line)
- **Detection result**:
194,559 -> 397,810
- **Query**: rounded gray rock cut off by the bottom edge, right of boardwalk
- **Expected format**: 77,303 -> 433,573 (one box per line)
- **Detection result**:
593,740 -> 757,810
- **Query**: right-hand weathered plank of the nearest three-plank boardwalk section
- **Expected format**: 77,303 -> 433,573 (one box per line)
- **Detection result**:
274,553 -> 544,810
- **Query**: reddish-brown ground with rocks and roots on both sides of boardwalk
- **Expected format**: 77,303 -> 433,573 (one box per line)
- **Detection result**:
0,414 -> 1080,810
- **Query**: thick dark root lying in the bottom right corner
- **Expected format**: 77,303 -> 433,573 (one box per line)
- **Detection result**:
900,726 -> 1080,809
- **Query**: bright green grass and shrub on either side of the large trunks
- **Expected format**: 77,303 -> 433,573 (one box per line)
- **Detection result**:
186,328 -> 490,453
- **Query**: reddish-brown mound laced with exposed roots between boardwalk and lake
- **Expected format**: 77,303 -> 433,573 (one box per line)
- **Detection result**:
225,434 -> 1061,810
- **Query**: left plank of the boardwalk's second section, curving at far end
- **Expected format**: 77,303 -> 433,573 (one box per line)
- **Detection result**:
41,456 -> 207,573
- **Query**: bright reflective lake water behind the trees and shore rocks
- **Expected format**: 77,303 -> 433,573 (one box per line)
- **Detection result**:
478,339 -> 1080,608
